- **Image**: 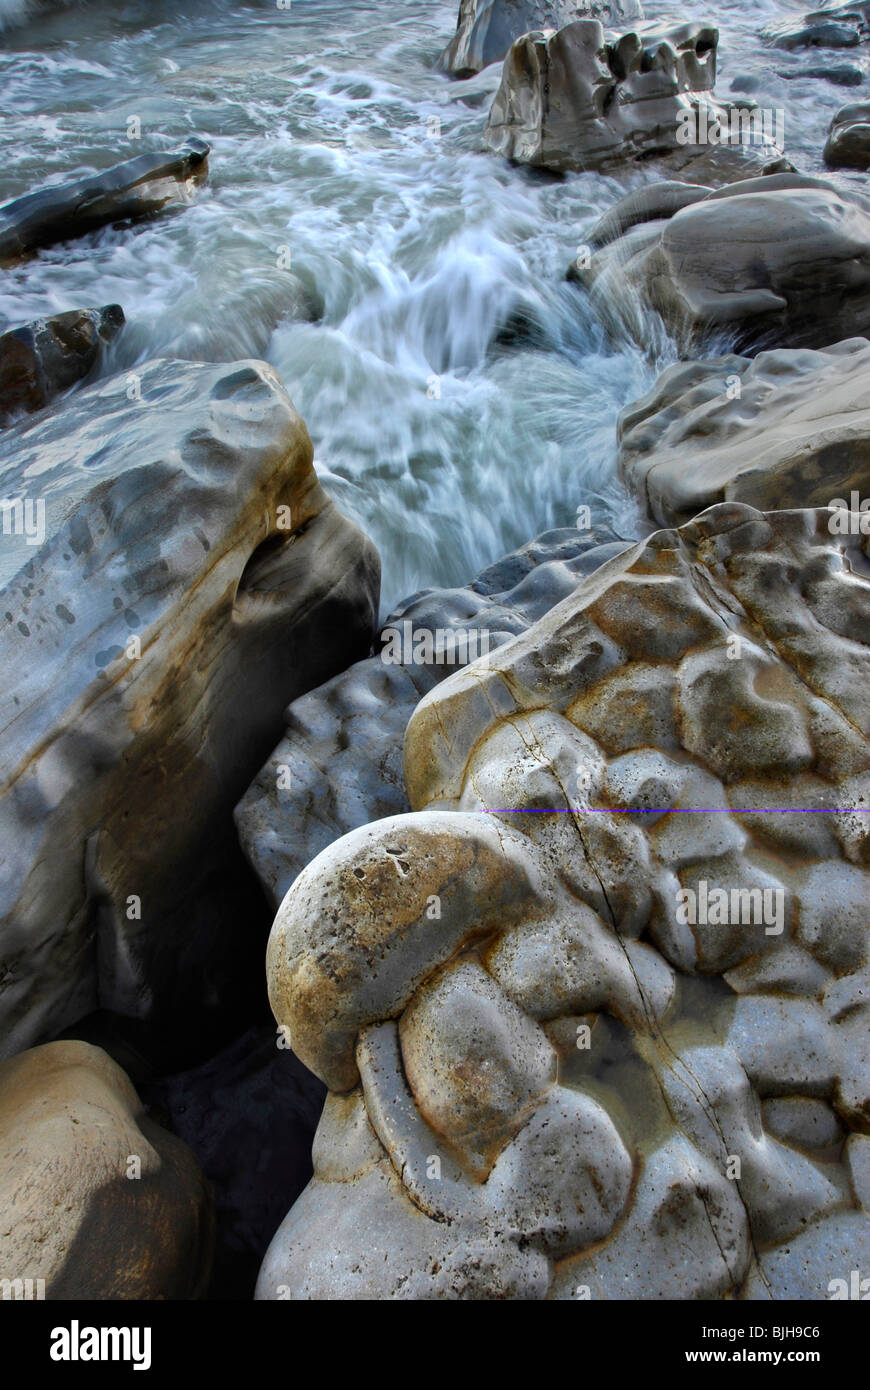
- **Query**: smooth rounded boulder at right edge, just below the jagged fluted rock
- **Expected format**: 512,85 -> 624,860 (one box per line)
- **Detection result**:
568,174 -> 870,356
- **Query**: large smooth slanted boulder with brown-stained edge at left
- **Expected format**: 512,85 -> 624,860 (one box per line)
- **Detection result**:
0,361 -> 378,1070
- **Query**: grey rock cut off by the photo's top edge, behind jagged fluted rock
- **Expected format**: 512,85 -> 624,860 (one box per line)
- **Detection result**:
441,0 -> 643,78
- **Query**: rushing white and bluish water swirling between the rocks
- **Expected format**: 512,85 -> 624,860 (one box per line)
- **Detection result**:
0,0 -> 862,605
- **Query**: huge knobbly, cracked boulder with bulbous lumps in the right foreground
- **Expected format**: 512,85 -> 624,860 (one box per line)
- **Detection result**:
257,503 -> 870,1300
